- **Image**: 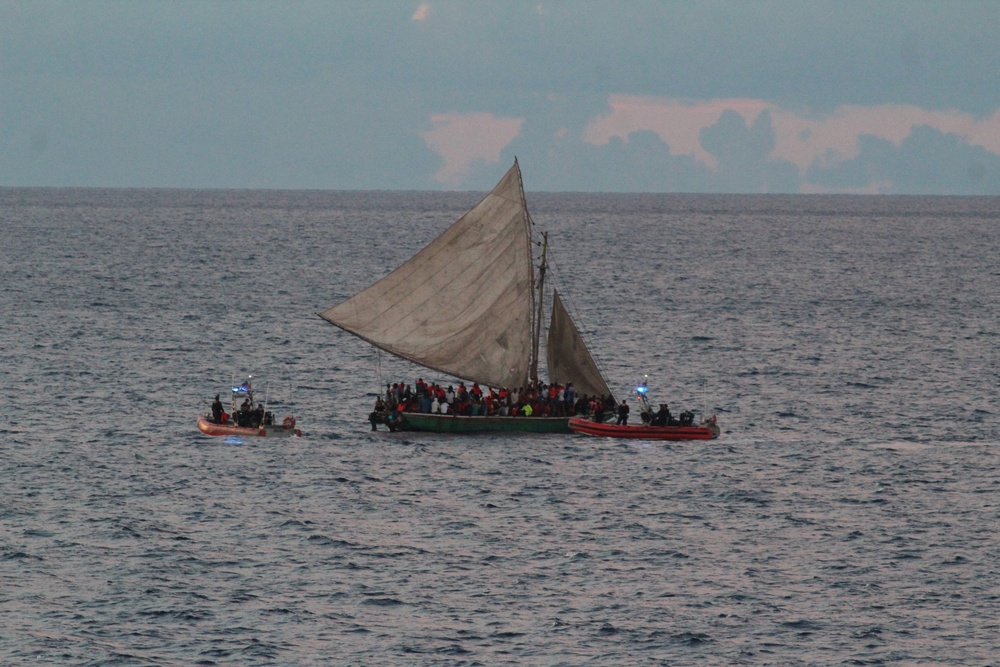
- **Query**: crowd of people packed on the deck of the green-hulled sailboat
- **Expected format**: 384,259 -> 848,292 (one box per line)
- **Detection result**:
368,378 -> 616,431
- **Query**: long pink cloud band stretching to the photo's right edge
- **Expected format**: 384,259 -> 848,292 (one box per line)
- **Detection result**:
584,95 -> 1000,175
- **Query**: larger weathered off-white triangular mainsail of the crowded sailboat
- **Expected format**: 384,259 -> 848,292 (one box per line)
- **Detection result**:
320,160 -> 534,387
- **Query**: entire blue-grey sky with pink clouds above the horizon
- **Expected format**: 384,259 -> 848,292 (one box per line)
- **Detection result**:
0,0 -> 1000,195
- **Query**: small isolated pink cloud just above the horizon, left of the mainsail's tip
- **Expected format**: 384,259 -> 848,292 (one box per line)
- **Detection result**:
420,112 -> 524,186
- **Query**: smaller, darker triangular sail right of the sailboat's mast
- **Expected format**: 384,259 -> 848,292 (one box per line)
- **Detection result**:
546,292 -> 611,396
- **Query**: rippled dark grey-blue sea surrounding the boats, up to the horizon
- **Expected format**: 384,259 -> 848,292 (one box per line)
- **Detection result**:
0,189 -> 1000,666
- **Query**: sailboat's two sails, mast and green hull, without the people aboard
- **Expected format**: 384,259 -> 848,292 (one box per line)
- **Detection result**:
319,158 -> 613,433
